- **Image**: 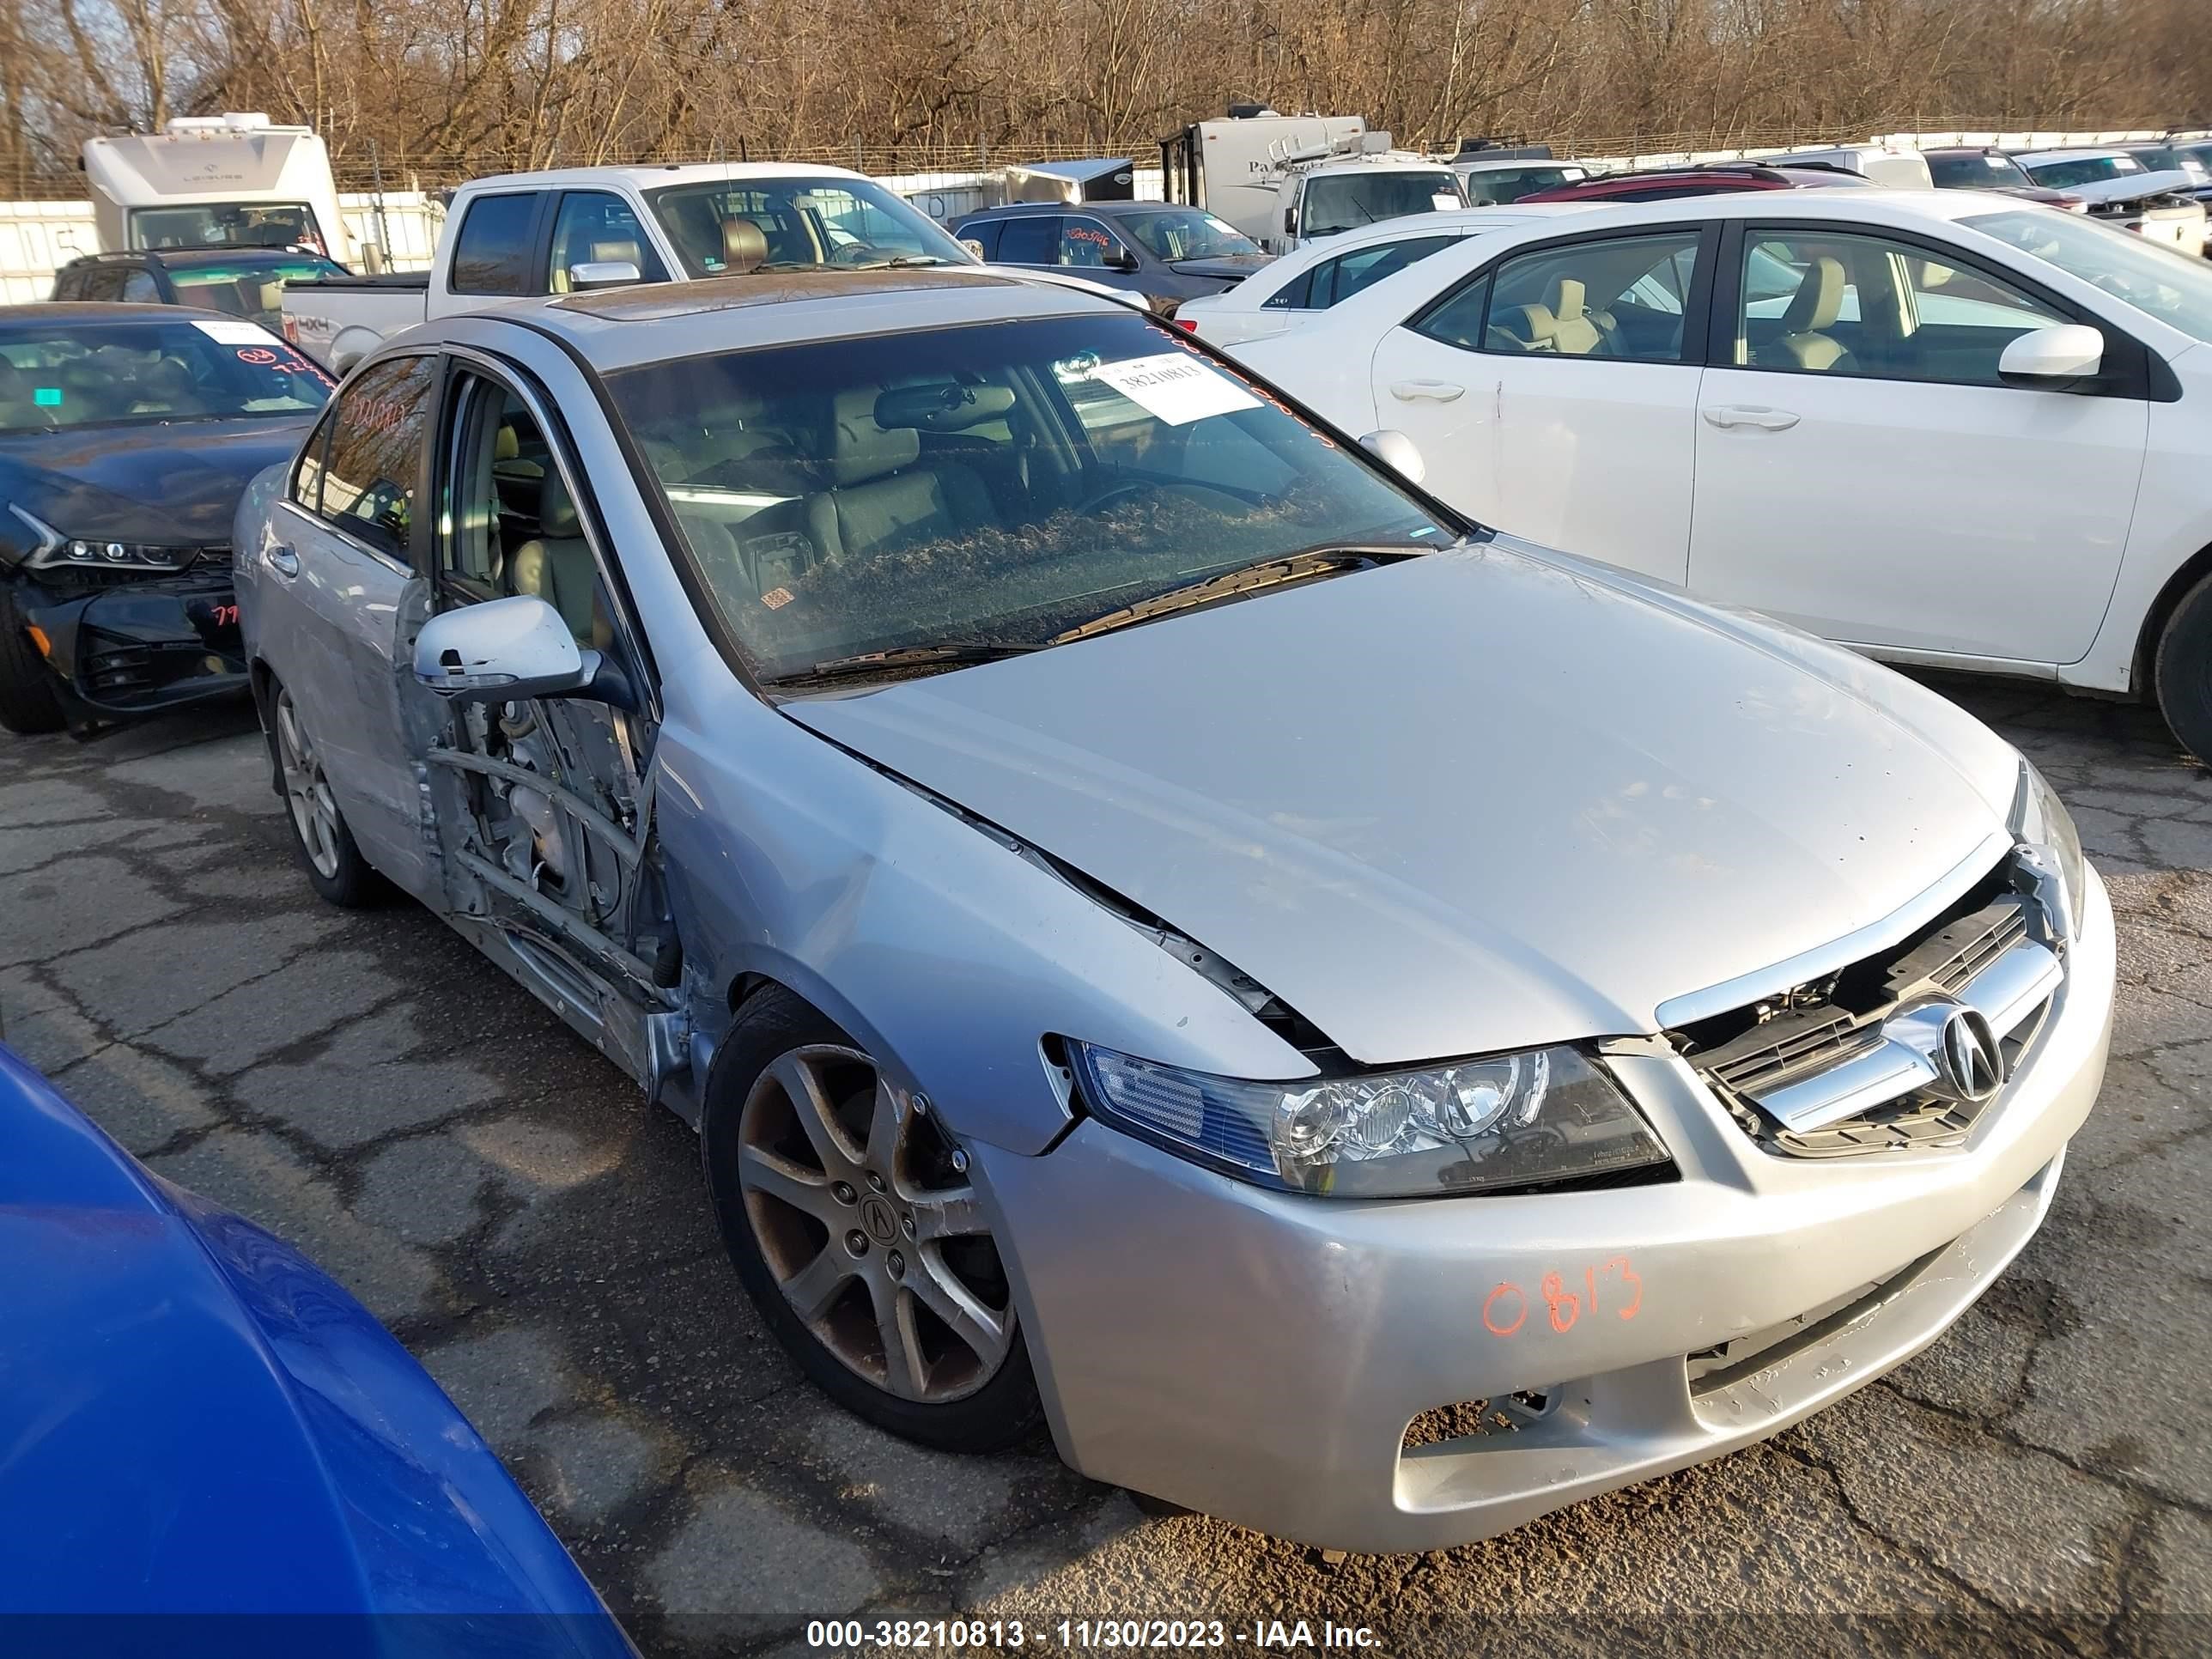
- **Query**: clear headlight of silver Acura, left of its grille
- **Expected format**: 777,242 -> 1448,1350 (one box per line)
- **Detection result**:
1068,1042 -> 1668,1199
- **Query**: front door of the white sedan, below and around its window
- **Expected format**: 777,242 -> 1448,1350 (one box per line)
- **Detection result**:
1690,222 -> 2150,664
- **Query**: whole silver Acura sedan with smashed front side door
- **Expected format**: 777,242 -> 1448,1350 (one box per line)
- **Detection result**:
237,270 -> 2112,1551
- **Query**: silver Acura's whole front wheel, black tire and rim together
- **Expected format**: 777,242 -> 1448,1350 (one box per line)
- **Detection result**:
699,987 -> 1042,1451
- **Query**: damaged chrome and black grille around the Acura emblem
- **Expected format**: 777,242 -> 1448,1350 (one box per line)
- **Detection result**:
1668,863 -> 2063,1157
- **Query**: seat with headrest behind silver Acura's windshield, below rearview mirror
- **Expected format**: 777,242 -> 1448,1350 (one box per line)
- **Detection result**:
807,387 -> 1000,560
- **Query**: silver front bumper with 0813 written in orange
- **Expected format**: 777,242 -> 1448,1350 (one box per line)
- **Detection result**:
975,878 -> 2112,1551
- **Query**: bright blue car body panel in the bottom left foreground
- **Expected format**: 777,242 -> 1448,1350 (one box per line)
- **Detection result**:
0,1048 -> 633,1659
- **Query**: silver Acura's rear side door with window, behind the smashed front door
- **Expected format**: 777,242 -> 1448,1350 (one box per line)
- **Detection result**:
257,352 -> 438,898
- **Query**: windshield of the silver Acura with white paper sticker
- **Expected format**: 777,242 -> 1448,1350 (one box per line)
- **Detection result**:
608,316 -> 1453,679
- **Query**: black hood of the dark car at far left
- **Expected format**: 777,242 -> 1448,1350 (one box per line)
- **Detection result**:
0,416 -> 314,546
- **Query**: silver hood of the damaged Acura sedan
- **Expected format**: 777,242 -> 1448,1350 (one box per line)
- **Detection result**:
785,544 -> 2017,1064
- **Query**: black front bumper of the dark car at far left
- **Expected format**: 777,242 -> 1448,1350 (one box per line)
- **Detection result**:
15,568 -> 246,719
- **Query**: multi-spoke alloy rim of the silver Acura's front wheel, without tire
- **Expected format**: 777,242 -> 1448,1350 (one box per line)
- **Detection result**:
737,1044 -> 1013,1405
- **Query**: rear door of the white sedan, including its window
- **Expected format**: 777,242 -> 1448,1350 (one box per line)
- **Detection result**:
1371,226 -> 1717,581
